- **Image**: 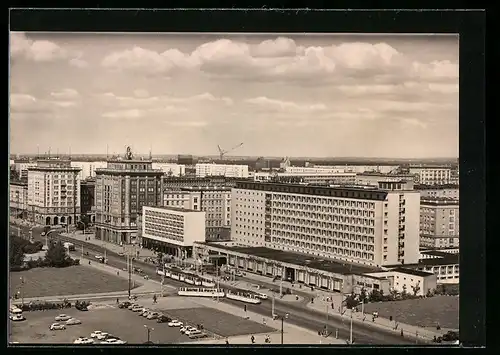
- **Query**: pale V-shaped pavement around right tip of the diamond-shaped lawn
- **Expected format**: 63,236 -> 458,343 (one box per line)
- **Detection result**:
186,298 -> 346,344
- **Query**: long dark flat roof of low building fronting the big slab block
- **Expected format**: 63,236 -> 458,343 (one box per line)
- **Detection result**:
199,242 -> 382,274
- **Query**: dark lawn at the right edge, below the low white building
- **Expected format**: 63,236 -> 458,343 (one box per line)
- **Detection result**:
365,296 -> 459,329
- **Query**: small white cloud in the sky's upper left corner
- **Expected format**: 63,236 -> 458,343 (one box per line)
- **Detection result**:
10,32 -> 84,67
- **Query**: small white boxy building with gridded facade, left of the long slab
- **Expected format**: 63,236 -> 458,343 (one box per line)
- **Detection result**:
141,206 -> 205,258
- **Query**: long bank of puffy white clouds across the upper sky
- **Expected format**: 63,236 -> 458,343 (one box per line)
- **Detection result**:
98,37 -> 458,84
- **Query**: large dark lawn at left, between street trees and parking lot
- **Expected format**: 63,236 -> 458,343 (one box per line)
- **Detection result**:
9,265 -> 135,298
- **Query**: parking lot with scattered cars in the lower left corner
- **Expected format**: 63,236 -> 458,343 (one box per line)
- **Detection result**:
10,305 -> 197,344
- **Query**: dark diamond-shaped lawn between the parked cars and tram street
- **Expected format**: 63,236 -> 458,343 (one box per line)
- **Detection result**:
155,307 -> 275,337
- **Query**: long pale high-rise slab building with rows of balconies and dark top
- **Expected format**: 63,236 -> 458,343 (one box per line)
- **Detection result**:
231,182 -> 420,267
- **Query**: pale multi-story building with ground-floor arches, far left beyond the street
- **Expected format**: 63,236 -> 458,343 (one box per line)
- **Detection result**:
28,159 -> 80,225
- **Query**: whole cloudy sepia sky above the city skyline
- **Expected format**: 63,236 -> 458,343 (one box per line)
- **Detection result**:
10,32 -> 458,158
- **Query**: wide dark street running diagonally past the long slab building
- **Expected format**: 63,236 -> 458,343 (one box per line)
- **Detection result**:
11,225 -> 414,344
